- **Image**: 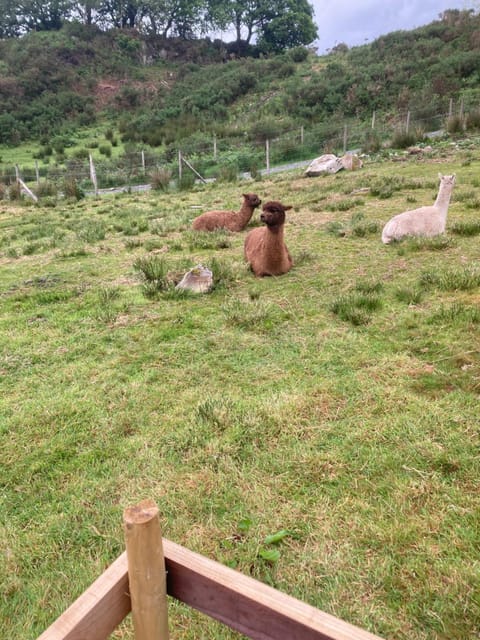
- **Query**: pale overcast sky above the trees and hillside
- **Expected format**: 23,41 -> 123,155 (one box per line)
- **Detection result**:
310,0 -> 480,54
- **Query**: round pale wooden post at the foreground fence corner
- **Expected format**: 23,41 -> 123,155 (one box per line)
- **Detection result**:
123,500 -> 169,640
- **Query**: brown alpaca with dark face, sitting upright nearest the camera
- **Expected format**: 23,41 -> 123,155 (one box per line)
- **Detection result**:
244,201 -> 293,278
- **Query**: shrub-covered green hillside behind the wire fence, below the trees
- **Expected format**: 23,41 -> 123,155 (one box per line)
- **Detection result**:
0,10 -> 480,154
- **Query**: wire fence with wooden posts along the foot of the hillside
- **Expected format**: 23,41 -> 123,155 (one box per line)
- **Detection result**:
0,94 -> 480,189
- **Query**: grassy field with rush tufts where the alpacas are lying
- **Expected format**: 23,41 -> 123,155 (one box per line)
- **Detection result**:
0,146 -> 480,640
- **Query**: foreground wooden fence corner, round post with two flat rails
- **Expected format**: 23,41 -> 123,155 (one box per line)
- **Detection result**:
37,500 -> 381,640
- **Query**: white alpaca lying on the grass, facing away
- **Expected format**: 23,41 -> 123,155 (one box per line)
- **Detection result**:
382,173 -> 455,244
